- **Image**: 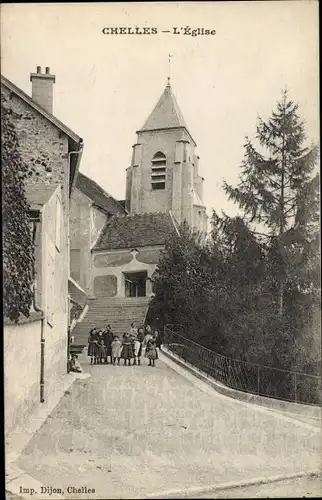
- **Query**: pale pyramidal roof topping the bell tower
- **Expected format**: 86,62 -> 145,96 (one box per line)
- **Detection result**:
140,83 -> 188,132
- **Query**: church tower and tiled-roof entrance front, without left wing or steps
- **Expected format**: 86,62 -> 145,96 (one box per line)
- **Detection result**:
91,81 -> 207,297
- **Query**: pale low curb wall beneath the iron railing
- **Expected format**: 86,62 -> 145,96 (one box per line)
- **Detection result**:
161,347 -> 322,422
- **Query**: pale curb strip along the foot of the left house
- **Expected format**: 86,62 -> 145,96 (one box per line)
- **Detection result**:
5,372 -> 91,469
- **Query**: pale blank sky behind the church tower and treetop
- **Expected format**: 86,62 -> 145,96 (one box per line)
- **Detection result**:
1,0 -> 319,215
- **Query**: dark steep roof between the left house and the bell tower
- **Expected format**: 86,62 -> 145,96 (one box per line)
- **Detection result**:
76,172 -> 126,215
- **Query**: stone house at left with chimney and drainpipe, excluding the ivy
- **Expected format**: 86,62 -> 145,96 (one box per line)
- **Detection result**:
1,67 -> 84,433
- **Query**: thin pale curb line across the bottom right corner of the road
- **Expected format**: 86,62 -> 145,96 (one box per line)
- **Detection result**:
145,470 -> 321,498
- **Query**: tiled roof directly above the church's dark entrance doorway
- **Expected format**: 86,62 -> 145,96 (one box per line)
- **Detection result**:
94,212 -> 174,251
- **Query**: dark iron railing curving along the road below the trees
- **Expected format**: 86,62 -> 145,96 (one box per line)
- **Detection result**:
163,325 -> 322,405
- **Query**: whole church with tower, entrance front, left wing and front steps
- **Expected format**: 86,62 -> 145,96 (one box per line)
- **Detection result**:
71,79 -> 208,342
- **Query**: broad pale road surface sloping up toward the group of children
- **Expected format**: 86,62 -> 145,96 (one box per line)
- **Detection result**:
17,354 -> 321,499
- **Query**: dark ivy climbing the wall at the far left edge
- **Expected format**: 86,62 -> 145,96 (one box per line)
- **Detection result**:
1,95 -> 34,322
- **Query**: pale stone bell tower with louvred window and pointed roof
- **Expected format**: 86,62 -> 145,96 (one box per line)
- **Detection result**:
126,78 -> 207,231
